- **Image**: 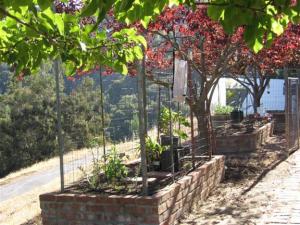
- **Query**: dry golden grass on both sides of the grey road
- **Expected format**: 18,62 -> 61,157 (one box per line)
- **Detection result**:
0,134 -> 145,225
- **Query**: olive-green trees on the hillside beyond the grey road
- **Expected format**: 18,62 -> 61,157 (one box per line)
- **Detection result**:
0,65 -> 108,177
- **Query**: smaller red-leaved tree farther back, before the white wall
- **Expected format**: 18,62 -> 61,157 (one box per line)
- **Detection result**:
231,24 -> 300,113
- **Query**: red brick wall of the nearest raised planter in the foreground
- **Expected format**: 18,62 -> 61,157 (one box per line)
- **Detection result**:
40,156 -> 224,225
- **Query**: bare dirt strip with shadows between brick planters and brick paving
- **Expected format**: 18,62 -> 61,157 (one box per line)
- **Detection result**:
180,136 -> 288,225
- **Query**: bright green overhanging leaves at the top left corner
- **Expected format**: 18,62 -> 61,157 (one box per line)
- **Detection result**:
0,0 -> 146,75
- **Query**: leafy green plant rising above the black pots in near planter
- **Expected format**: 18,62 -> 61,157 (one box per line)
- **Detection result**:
159,107 -> 190,139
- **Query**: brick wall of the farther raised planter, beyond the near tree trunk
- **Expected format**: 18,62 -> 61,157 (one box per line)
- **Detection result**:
216,122 -> 274,154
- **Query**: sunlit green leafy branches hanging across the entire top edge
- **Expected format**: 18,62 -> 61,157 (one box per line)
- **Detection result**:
0,0 -> 300,78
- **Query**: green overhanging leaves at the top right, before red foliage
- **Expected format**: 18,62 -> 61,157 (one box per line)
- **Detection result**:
208,0 -> 300,52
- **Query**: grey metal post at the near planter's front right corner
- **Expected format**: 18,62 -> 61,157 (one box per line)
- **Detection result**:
137,51 -> 148,195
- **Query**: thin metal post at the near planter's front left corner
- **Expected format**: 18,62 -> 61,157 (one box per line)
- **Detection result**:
54,59 -> 65,192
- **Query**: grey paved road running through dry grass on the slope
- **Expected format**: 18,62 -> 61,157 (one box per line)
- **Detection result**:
0,156 -> 92,203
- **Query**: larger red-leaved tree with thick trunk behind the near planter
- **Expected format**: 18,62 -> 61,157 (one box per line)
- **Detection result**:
144,6 -> 243,153
